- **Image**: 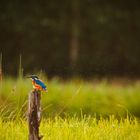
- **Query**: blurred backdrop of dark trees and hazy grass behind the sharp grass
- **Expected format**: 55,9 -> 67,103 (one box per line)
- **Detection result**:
0,0 -> 140,118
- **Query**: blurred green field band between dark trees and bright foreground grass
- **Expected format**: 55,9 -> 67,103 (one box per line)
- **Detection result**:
0,78 -> 140,119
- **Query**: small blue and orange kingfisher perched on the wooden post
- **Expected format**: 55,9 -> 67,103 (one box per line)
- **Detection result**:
27,75 -> 48,92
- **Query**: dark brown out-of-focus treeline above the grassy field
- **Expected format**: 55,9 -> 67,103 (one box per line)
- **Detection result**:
0,0 -> 140,77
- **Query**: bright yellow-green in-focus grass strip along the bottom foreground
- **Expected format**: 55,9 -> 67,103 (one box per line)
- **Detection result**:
0,116 -> 140,140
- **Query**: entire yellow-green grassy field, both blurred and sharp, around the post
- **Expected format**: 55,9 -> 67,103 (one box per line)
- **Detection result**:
0,78 -> 140,140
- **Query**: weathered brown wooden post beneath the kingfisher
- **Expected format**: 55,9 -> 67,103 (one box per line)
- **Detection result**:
28,90 -> 43,140
